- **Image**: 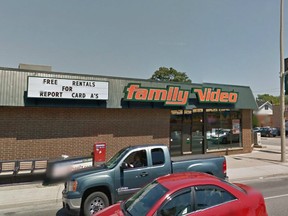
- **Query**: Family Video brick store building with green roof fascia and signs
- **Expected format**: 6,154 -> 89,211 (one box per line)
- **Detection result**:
0,68 -> 257,161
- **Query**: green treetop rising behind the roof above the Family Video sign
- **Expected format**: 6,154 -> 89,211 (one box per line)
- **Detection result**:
150,67 -> 192,83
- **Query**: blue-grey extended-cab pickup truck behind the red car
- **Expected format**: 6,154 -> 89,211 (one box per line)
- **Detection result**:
62,144 -> 227,216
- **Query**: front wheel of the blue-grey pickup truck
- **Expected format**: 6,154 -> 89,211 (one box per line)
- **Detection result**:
83,192 -> 109,216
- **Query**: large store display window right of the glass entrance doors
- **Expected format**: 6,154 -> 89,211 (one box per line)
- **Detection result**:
206,109 -> 242,150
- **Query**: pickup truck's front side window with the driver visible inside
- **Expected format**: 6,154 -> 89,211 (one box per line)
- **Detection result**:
124,150 -> 147,168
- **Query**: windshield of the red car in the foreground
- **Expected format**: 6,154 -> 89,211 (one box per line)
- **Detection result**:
124,181 -> 168,215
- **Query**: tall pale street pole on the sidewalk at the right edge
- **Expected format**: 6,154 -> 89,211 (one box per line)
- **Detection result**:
280,0 -> 286,162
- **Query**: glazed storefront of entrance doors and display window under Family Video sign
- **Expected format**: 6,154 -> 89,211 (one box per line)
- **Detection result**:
170,109 -> 242,156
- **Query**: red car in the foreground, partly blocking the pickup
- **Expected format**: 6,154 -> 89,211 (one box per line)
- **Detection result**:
94,172 -> 268,216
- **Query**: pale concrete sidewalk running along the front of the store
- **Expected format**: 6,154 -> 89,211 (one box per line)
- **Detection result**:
0,138 -> 288,214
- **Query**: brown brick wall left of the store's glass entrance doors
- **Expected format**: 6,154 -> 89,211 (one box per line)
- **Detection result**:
0,107 -> 170,160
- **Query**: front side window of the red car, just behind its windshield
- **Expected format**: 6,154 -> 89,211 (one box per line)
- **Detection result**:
157,190 -> 192,216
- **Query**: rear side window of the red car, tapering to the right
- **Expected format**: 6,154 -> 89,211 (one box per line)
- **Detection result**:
194,185 -> 236,211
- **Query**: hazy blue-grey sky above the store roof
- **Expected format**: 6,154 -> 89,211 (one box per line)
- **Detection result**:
0,0 -> 288,96
